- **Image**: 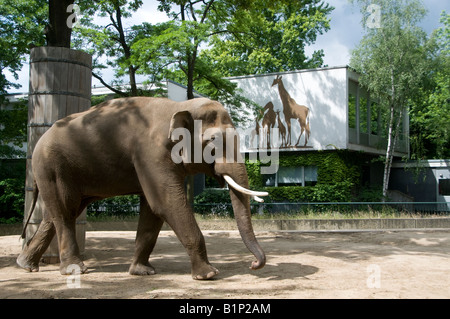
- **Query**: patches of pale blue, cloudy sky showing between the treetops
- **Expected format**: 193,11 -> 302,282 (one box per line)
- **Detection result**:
4,0 -> 450,93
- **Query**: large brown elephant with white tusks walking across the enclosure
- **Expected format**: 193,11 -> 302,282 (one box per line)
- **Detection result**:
17,97 -> 267,279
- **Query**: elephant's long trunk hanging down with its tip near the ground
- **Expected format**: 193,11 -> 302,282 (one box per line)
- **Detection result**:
216,163 -> 266,269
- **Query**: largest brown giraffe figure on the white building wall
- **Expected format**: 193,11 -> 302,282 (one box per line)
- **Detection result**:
272,75 -> 311,146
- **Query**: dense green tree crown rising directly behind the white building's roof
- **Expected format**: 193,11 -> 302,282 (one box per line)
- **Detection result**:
202,0 -> 334,76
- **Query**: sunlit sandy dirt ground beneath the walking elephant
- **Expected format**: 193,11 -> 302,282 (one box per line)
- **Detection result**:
0,230 -> 450,299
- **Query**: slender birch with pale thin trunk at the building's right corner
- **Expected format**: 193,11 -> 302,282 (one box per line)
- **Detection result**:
350,0 -> 430,196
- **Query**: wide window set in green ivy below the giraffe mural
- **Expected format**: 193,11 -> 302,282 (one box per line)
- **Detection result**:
262,166 -> 317,186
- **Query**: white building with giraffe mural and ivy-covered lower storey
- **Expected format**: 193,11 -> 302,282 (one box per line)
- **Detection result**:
9,66 -> 450,209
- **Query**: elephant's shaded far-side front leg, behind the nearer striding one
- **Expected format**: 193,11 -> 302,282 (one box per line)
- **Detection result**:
129,196 -> 164,276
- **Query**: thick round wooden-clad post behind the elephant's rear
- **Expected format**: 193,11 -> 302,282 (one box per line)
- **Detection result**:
24,47 -> 92,263
